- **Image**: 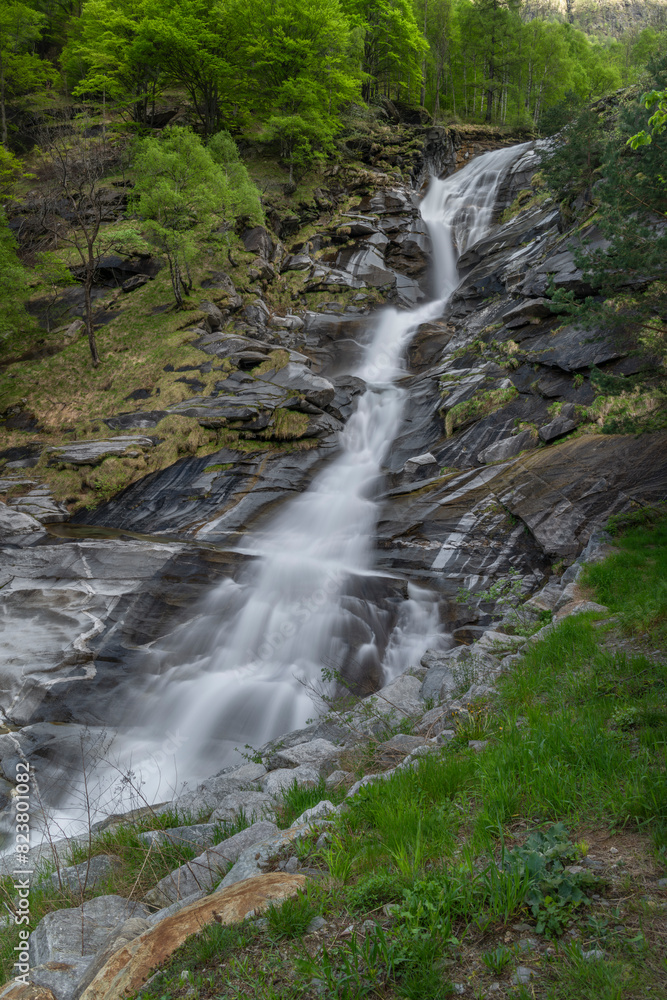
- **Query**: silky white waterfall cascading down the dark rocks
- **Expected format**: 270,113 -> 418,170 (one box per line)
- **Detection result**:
41,146 -> 524,828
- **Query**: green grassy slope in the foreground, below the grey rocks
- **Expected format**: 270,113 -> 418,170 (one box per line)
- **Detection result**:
0,511 -> 667,1000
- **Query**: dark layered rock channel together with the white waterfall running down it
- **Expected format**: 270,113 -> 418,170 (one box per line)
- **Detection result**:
0,130 -> 667,836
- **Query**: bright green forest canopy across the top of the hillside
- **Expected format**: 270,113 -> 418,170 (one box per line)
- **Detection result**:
0,0 -> 667,152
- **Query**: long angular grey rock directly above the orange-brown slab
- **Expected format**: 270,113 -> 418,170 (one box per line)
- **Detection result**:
144,822 -> 278,907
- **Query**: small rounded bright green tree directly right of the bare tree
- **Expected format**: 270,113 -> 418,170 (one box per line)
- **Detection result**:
134,128 -> 232,308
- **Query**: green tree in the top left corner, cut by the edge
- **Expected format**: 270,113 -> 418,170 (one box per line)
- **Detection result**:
0,3 -> 54,146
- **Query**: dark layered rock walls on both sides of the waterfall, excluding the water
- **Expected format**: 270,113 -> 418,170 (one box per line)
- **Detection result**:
0,119 -> 667,836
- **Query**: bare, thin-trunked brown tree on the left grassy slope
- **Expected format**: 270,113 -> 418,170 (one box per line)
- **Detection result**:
41,121 -> 138,368
